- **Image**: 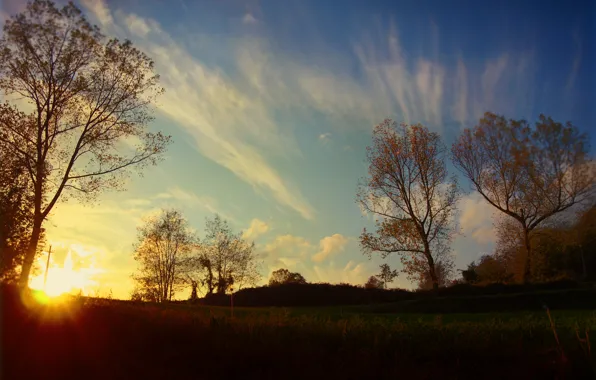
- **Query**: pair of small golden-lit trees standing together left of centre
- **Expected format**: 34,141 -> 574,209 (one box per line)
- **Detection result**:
131,210 -> 260,302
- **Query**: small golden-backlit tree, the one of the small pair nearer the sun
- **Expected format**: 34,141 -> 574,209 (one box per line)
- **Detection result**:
133,210 -> 197,302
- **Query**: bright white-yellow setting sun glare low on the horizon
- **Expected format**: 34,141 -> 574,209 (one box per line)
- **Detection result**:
29,250 -> 102,297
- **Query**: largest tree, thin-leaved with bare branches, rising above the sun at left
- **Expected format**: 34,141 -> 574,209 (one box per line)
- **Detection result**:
0,0 -> 170,287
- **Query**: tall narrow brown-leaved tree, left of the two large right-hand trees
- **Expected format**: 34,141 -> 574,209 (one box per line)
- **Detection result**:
357,120 -> 459,289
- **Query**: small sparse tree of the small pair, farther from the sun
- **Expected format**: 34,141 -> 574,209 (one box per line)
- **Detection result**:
200,214 -> 260,294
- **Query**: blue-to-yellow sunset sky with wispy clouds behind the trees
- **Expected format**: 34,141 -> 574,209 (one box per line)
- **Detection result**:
0,0 -> 596,298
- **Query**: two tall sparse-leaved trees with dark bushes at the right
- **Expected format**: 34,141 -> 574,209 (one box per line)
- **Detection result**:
357,112 -> 596,289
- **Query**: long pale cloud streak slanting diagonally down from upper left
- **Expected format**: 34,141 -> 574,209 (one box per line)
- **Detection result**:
86,1 -> 322,219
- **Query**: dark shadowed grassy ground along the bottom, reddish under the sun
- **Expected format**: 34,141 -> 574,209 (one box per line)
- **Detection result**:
1,291 -> 596,379
